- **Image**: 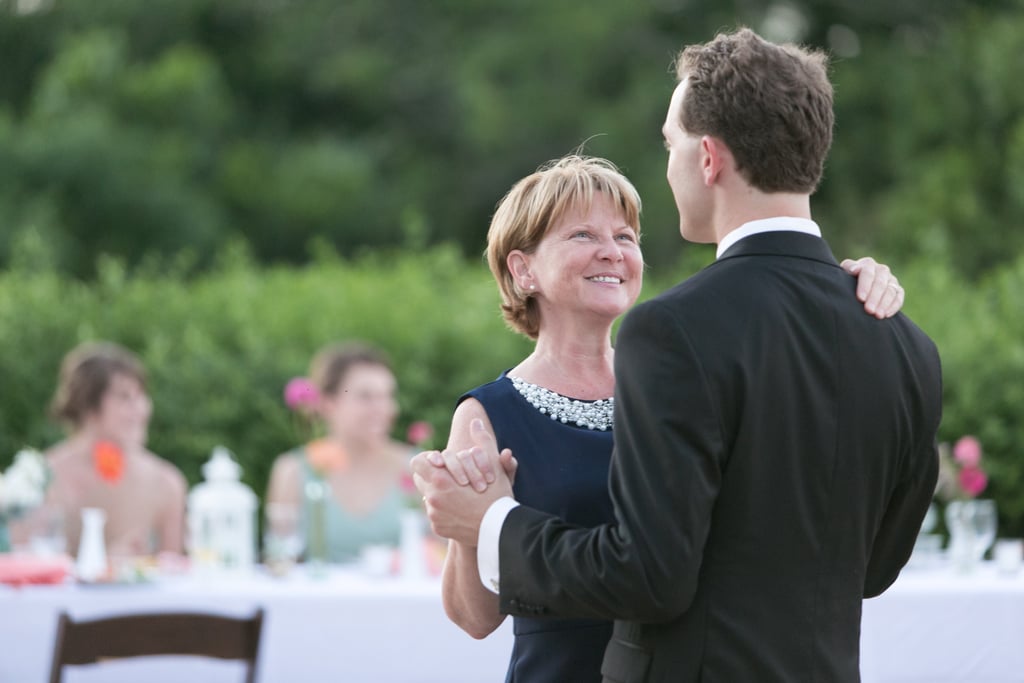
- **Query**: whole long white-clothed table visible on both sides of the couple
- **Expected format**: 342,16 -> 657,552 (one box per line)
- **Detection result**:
0,563 -> 1024,683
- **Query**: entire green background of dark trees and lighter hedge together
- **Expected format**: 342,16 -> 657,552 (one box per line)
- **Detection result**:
0,0 -> 1024,536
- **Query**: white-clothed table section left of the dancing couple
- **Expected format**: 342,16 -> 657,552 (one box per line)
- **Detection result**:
0,567 -> 511,683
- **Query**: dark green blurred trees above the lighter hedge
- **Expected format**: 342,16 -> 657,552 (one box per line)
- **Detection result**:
0,0 -> 1024,275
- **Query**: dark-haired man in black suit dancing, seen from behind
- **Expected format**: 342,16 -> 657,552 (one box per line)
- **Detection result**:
414,30 -> 941,683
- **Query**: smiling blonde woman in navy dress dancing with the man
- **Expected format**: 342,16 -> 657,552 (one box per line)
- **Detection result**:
432,156 -> 899,683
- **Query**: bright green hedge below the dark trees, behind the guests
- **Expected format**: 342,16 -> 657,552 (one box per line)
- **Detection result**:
0,248 -> 1024,536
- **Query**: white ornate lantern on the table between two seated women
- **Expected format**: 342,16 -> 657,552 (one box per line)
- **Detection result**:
188,445 -> 256,571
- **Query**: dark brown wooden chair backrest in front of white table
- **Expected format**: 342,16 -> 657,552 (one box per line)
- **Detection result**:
50,608 -> 263,683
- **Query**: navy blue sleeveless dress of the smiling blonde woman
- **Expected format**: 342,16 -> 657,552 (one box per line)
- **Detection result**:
459,373 -> 614,683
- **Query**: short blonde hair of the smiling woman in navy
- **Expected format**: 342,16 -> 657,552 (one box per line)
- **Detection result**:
486,155 -> 640,339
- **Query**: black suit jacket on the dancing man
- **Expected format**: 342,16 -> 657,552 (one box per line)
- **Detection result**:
500,232 -> 941,683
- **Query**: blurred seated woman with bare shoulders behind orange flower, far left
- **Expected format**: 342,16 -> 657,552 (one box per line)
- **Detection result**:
12,342 -> 187,557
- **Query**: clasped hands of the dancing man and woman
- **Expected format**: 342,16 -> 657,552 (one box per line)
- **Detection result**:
412,419 -> 518,547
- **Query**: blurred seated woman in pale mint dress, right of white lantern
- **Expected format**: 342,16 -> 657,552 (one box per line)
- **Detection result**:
266,344 -> 413,562
